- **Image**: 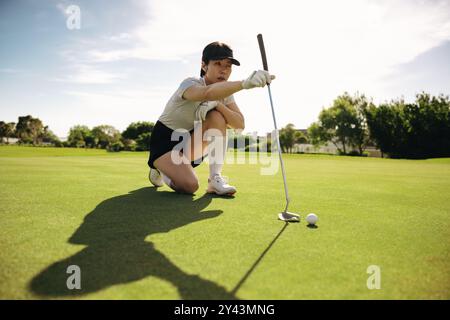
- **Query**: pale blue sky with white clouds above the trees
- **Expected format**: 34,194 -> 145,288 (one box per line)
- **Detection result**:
0,0 -> 450,137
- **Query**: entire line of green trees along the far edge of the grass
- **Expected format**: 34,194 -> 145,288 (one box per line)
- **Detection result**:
0,92 -> 450,159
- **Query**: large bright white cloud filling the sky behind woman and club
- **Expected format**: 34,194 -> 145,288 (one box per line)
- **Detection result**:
56,0 -> 450,131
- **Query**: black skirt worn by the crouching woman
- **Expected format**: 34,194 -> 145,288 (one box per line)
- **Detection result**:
147,120 -> 206,169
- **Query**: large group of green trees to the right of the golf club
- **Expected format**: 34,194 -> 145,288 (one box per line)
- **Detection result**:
308,92 -> 450,159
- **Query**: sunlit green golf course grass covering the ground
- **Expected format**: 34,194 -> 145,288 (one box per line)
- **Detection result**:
0,146 -> 450,299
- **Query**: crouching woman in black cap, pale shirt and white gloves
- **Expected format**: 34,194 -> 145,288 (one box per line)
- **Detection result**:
148,42 -> 275,195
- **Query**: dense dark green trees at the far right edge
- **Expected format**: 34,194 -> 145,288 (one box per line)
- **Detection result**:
365,92 -> 450,159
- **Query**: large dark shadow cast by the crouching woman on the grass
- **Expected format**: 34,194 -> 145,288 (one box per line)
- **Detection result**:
29,187 -> 236,299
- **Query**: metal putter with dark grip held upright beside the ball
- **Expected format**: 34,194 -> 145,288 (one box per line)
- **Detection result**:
257,34 -> 300,222
